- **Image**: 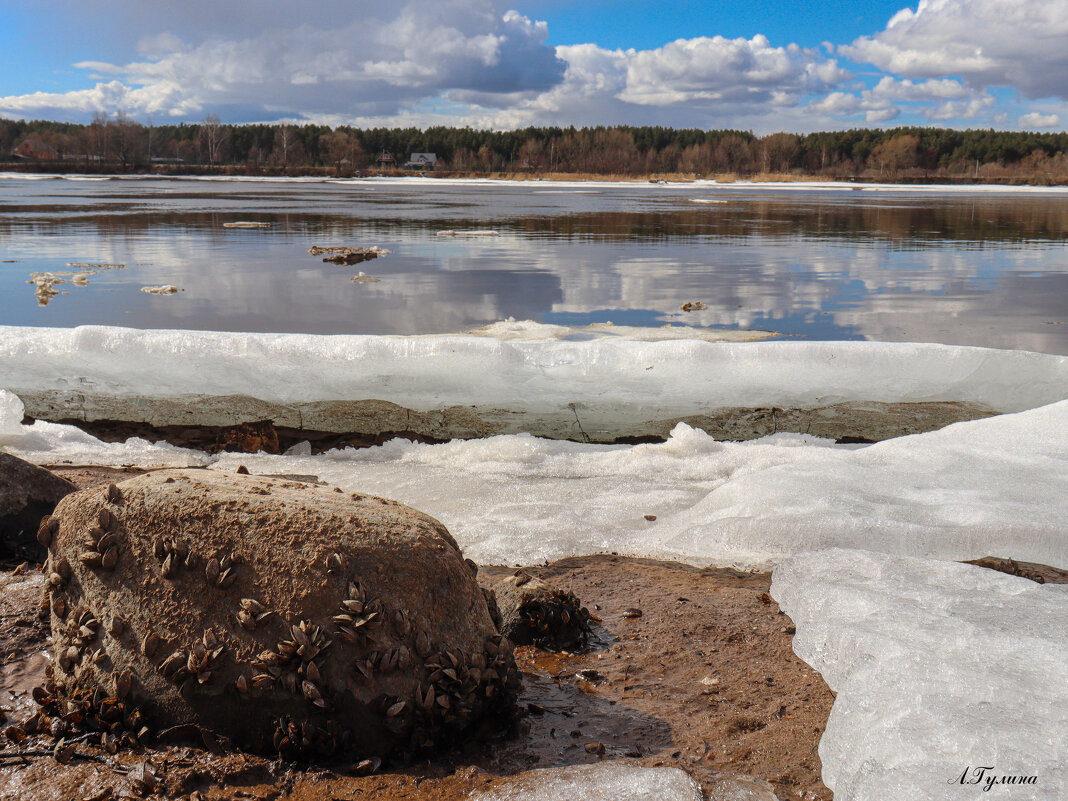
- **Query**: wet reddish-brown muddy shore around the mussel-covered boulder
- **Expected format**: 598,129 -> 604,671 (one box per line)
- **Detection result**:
0,467 -> 1068,801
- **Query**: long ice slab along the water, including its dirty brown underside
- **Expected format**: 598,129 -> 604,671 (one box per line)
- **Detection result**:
0,324 -> 1068,441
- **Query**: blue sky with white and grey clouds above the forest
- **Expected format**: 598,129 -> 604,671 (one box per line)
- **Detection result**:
0,0 -> 1068,135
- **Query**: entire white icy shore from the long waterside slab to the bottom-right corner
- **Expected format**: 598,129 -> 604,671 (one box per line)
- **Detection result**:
0,328 -> 1068,801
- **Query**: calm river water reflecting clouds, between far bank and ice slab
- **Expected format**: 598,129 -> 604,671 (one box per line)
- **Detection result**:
0,176 -> 1068,354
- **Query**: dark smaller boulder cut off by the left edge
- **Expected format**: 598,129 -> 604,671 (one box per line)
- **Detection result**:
0,453 -> 75,559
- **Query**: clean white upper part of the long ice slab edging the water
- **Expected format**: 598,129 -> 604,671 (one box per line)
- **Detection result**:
0,326 -> 1068,419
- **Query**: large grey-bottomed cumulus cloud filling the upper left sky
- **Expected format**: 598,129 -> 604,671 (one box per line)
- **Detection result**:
0,0 -> 565,119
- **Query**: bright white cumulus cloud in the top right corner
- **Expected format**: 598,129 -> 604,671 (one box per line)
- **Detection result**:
838,0 -> 1068,98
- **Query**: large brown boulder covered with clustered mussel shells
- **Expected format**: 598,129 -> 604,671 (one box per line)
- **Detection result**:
42,470 -> 519,757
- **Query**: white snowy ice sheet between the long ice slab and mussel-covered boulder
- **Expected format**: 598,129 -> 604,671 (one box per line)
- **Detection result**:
7,402 -> 1068,568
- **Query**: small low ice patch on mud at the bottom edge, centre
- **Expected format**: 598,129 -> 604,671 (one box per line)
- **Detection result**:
471,761 -> 704,801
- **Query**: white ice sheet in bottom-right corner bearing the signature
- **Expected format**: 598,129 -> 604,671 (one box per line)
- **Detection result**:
771,549 -> 1068,801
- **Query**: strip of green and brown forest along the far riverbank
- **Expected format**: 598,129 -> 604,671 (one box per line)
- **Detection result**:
0,113 -> 1068,185
